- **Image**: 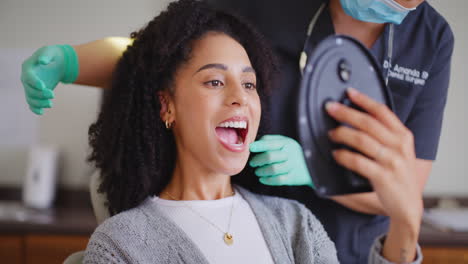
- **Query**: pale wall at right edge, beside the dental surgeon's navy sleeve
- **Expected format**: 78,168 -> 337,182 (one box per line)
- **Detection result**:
425,0 -> 468,196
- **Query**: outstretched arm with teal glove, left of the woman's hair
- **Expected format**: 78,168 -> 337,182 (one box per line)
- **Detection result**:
21,37 -> 132,115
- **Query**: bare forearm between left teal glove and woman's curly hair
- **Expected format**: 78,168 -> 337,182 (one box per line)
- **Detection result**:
73,37 -> 132,88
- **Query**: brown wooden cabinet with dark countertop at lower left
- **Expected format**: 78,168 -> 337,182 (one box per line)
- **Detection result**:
0,189 -> 97,264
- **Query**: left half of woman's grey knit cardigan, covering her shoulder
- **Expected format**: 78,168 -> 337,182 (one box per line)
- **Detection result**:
85,198 -> 200,263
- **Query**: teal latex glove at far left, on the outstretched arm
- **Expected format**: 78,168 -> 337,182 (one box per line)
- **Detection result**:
21,45 -> 78,115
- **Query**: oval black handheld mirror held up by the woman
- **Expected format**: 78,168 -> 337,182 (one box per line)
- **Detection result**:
297,35 -> 393,196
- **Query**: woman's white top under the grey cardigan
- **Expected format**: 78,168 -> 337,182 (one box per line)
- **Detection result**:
153,191 -> 273,264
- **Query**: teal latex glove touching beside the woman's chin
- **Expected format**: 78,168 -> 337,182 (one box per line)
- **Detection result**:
249,135 -> 315,188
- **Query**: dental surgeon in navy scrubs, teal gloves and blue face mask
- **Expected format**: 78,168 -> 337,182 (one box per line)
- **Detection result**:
22,0 -> 454,263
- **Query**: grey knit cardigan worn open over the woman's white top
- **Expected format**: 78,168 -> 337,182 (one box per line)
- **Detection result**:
84,187 -> 422,264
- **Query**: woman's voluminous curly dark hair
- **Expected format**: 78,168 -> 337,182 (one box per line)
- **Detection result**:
88,0 -> 277,215
